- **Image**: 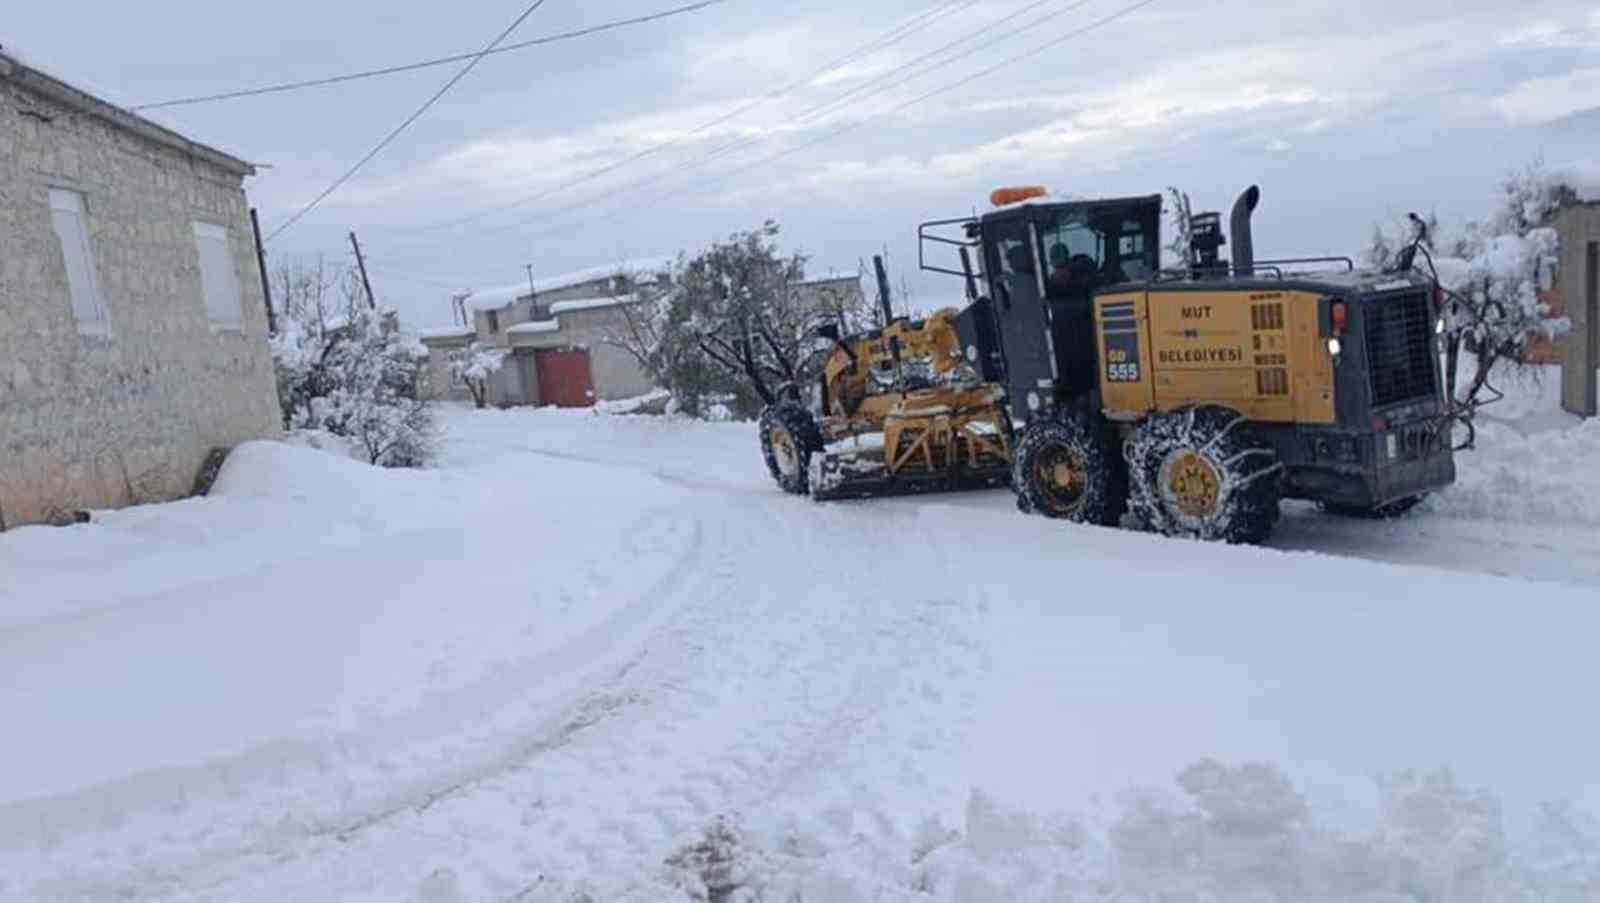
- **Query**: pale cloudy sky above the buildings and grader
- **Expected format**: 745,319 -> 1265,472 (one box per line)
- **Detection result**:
12,0 -> 1600,327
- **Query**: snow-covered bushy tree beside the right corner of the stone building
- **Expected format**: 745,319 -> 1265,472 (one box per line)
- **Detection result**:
270,264 -> 434,468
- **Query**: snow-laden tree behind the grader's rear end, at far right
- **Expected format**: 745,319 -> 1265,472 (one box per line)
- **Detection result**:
1366,163 -> 1571,407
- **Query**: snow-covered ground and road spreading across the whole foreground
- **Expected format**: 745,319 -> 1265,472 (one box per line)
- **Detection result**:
0,368 -> 1600,903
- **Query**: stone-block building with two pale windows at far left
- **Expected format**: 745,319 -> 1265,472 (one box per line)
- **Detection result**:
0,50 -> 280,528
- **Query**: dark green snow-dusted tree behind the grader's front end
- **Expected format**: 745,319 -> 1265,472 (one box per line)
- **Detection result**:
621,223 -> 870,413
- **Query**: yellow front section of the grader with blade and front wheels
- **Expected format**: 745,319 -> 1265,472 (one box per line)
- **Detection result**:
760,260 -> 1011,501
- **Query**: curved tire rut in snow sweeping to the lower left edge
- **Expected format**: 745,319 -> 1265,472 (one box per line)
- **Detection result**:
0,509 -> 713,900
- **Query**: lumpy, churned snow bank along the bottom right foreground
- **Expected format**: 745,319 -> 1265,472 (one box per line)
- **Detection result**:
672,761 -> 1600,903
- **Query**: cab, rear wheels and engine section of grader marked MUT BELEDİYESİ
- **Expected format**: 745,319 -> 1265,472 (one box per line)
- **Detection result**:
920,180 -> 1456,543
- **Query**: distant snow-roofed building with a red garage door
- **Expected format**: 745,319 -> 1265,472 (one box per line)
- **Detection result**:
421,258 -> 672,407
